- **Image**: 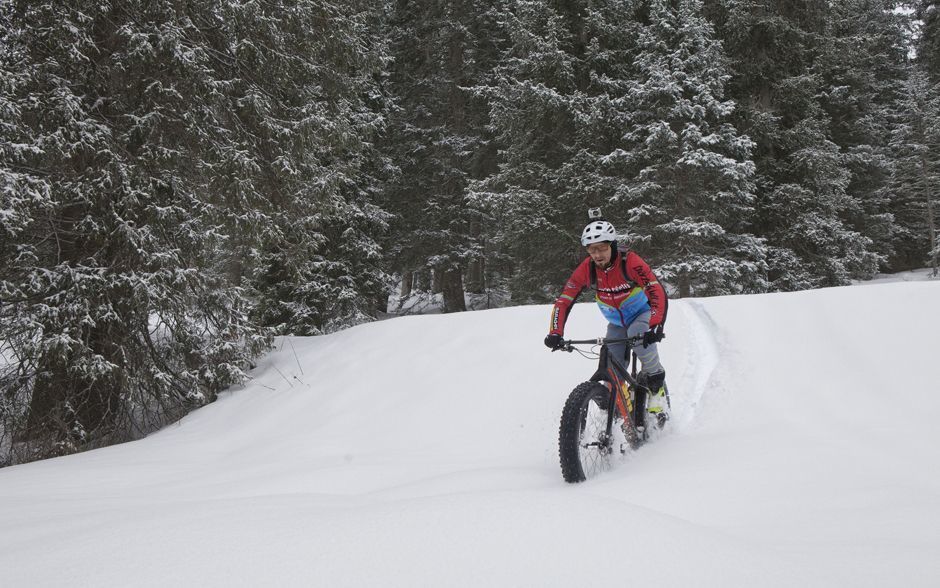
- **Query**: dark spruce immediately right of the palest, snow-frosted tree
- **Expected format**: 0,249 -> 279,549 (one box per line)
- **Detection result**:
709,0 -> 880,290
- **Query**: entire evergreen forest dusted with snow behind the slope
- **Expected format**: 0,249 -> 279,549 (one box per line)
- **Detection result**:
0,0 -> 940,466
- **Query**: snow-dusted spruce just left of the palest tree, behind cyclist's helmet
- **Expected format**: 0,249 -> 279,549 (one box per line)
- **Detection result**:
473,0 -> 637,303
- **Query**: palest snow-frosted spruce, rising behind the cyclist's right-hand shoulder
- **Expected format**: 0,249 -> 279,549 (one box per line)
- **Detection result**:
613,0 -> 767,297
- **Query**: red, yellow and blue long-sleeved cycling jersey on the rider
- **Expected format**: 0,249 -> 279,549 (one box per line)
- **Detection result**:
549,251 -> 668,335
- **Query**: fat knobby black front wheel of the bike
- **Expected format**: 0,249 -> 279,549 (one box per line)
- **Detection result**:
558,382 -> 613,483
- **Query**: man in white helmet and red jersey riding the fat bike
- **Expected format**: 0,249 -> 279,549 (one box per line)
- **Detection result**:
545,220 -> 669,426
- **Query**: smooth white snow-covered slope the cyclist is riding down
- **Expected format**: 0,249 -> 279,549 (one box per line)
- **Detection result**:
0,281 -> 940,588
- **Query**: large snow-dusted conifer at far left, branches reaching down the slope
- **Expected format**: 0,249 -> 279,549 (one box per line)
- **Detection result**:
0,0 -> 269,461
